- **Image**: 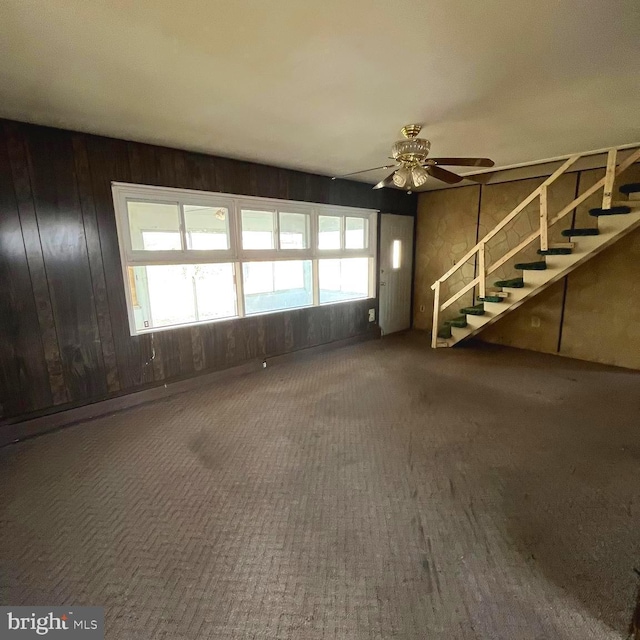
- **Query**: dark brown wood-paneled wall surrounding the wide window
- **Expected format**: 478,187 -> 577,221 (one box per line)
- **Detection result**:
0,120 -> 416,428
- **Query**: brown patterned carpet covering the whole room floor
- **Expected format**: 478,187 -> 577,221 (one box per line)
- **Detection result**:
0,334 -> 640,640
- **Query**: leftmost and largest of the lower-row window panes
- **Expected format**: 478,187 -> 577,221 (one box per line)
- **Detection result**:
129,263 -> 237,331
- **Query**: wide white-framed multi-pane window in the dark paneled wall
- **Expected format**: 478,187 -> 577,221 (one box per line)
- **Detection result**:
113,183 -> 377,335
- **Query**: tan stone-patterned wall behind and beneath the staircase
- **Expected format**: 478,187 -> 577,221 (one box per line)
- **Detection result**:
414,163 -> 640,369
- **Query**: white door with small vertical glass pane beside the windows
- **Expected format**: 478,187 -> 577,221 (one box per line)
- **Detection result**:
379,213 -> 414,335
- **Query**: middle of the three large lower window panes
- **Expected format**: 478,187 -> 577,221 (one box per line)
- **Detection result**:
242,260 -> 313,315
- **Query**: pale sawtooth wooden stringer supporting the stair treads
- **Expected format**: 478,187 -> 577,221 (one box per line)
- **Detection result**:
438,208 -> 640,347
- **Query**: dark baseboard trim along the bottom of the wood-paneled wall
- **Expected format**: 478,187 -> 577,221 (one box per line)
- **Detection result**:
0,328 -> 380,447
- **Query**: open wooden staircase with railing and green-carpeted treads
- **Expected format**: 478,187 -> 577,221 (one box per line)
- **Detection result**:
431,149 -> 640,348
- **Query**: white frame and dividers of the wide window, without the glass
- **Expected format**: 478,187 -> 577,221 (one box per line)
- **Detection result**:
111,182 -> 379,336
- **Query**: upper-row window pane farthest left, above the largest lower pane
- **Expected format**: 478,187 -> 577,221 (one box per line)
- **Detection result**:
127,200 -> 182,251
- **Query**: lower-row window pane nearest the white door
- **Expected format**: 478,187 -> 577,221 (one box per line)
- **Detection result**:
318,258 -> 369,304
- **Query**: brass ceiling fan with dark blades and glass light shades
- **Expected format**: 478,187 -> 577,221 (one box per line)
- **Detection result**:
332,124 -> 495,193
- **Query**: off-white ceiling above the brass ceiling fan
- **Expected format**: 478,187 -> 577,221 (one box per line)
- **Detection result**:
0,0 -> 640,189
